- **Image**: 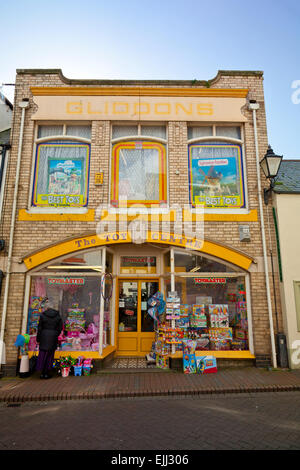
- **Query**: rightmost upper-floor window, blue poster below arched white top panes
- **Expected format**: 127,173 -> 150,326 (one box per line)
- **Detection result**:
188,125 -> 245,209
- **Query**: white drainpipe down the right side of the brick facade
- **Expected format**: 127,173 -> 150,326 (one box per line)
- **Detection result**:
249,100 -> 277,368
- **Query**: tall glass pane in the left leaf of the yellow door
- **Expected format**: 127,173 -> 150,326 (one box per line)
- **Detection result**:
119,281 -> 138,332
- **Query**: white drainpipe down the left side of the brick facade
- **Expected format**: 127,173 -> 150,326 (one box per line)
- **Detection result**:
0,98 -> 29,367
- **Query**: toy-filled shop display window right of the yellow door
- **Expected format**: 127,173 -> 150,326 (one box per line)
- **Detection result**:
165,274 -> 249,351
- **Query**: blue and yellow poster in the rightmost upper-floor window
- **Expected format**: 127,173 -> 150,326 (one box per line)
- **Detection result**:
189,144 -> 245,208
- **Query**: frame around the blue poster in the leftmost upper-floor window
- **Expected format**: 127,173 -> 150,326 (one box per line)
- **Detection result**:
27,121 -> 92,214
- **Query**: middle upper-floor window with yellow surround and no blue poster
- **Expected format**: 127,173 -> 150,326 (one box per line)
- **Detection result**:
111,124 -> 167,207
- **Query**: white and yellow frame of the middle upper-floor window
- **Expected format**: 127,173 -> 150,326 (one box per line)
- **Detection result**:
109,121 -> 169,208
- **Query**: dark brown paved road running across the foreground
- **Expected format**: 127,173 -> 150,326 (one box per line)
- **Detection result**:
0,392 -> 300,450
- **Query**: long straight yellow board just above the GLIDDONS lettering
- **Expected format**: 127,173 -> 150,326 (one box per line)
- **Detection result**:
30,86 -> 249,98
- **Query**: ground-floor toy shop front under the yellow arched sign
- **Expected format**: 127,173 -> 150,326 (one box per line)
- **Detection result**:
23,232 -> 254,359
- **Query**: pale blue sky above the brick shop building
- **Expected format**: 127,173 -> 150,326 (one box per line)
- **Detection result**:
0,0 -> 300,159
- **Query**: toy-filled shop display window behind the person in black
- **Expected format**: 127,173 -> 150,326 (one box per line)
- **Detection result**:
27,273 -> 111,351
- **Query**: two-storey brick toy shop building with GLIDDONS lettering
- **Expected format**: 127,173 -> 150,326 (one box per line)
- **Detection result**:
0,69 -> 282,374
